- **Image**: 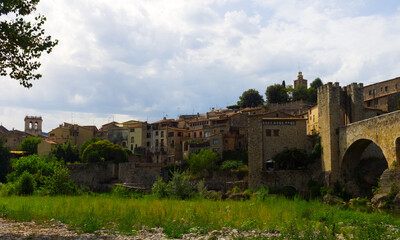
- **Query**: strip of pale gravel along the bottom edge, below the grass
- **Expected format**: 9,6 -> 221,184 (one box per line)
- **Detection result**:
0,218 -> 278,240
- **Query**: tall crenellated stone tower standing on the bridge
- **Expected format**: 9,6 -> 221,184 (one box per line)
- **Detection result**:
318,82 -> 364,186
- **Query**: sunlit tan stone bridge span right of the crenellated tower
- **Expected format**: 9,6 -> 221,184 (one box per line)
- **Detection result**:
338,111 -> 400,172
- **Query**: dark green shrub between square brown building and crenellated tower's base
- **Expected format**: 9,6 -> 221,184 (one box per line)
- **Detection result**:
273,148 -> 308,169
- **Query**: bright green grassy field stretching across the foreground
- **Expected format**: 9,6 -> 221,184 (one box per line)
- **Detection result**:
0,195 -> 400,239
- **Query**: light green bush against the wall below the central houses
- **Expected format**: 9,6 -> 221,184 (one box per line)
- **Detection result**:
186,149 -> 219,173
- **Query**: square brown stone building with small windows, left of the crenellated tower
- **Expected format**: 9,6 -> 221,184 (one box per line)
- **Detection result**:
248,112 -> 312,188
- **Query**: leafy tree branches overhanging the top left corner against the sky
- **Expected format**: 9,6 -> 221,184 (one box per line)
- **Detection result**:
0,0 -> 58,88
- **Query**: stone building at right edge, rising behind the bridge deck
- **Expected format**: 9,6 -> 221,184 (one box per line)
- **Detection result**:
364,77 -> 400,112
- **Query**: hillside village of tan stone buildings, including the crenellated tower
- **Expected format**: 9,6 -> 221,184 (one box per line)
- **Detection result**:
0,72 -> 400,195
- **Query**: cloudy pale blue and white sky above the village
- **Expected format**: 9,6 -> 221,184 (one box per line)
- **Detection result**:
0,0 -> 400,131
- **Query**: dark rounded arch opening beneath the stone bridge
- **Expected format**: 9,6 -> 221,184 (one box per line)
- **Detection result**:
340,139 -> 388,197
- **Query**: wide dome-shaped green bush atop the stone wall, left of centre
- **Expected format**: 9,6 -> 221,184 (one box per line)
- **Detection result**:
82,140 -> 128,163
